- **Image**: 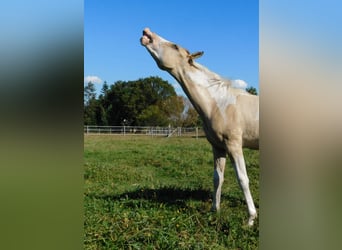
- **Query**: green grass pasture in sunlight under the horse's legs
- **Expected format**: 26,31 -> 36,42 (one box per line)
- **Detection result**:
84,135 -> 259,249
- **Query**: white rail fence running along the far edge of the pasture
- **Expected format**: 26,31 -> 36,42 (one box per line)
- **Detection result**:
84,125 -> 204,138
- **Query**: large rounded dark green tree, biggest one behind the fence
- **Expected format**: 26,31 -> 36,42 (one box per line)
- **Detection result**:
103,77 -> 181,126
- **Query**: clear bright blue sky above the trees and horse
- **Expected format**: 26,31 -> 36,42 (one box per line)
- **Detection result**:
84,0 -> 259,94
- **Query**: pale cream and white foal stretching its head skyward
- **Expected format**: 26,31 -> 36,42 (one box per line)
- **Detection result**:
140,28 -> 259,226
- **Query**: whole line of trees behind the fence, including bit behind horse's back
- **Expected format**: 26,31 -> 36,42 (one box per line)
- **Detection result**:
84,76 -> 257,127
